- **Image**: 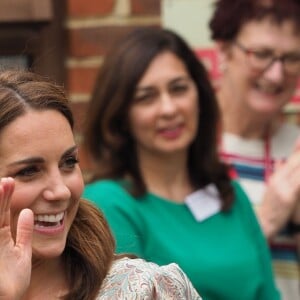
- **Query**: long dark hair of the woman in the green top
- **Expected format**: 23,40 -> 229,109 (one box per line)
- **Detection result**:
84,27 -> 233,209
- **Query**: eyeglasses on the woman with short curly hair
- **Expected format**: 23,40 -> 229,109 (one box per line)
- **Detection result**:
234,42 -> 300,75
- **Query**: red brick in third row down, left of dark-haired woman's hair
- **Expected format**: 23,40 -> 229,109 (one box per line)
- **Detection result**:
67,67 -> 99,93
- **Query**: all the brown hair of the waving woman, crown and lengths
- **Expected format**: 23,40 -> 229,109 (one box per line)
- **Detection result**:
0,71 -> 115,300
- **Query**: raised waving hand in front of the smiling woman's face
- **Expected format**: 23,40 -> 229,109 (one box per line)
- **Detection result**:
0,178 -> 33,300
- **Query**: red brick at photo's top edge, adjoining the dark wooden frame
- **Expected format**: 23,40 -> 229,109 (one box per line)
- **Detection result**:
67,0 -> 115,17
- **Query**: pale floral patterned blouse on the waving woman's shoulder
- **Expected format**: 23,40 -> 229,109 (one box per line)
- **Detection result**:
97,257 -> 202,300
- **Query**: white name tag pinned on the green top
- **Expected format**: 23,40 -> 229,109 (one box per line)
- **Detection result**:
185,183 -> 221,222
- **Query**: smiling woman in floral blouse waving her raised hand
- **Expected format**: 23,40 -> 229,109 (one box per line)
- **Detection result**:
0,71 -> 201,300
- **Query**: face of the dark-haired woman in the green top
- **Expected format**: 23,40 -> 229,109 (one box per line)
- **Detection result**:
128,51 -> 199,156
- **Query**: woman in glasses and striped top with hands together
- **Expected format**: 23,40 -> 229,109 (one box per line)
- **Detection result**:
210,0 -> 300,300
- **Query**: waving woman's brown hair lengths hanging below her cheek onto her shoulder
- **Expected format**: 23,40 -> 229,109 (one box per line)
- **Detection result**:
63,199 -> 115,300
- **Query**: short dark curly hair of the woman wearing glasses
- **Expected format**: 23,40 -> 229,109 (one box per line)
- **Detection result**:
209,0 -> 300,41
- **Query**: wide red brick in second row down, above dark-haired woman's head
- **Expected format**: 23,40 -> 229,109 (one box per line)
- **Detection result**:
68,24 -> 159,57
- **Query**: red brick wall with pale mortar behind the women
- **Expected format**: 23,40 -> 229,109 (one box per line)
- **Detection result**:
65,0 -> 161,176
